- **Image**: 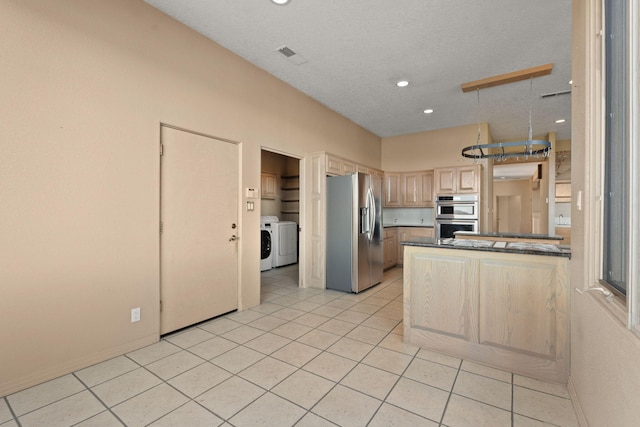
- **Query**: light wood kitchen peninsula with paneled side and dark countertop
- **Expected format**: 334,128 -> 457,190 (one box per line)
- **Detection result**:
402,238 -> 571,383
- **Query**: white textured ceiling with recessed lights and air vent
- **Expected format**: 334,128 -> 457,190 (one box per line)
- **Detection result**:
145,0 -> 571,141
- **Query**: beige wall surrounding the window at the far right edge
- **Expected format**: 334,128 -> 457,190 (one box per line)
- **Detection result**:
570,0 -> 640,426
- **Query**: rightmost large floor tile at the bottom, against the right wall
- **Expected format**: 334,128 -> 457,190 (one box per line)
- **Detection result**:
513,386 -> 578,427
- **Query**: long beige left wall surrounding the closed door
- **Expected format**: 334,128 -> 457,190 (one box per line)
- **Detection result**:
0,0 -> 380,396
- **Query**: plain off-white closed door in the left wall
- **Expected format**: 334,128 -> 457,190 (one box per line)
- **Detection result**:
160,126 -> 238,334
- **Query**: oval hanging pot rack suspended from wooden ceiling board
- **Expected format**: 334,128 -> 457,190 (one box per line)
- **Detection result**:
462,64 -> 551,161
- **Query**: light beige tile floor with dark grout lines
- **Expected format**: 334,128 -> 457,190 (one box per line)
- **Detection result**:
0,266 -> 578,427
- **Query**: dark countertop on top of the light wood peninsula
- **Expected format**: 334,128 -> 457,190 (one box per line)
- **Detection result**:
400,237 -> 571,258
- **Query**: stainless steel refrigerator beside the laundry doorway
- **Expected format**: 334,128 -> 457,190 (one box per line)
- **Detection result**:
326,172 -> 384,293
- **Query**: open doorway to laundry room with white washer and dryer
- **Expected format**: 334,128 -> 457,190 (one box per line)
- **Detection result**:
260,149 -> 301,290
